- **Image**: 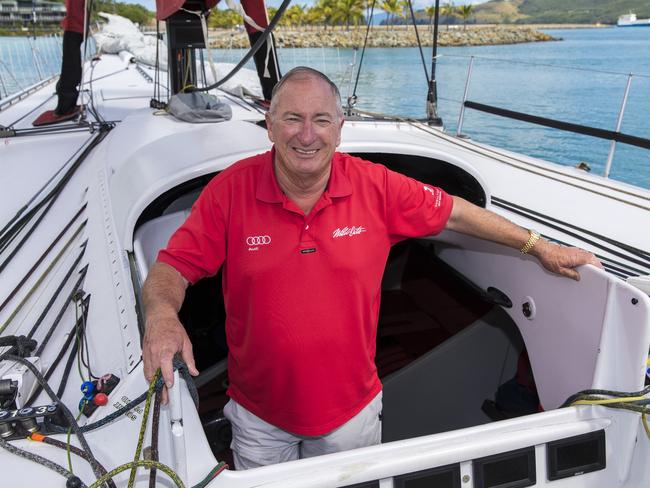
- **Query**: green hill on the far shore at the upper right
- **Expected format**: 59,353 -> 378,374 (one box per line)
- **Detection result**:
474,0 -> 650,24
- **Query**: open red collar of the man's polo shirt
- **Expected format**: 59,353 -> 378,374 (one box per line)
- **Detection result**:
255,146 -> 352,203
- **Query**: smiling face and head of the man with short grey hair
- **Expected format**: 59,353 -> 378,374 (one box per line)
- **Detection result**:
266,75 -> 343,181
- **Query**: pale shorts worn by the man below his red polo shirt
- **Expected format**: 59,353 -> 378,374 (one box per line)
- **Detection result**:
223,392 -> 382,469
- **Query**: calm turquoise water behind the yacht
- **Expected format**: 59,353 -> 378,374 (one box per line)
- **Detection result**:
0,28 -> 650,188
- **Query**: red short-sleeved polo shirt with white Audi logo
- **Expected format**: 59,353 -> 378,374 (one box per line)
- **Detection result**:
158,151 -> 452,436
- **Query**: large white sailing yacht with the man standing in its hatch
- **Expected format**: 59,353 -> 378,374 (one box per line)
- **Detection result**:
0,3 -> 650,488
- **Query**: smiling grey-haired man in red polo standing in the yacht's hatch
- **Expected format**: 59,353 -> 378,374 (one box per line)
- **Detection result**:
143,68 -> 599,468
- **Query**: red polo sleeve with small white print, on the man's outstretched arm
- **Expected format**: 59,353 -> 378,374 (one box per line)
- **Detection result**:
386,170 -> 454,243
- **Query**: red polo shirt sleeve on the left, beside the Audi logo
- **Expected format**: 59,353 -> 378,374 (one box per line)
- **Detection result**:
158,184 -> 226,283
